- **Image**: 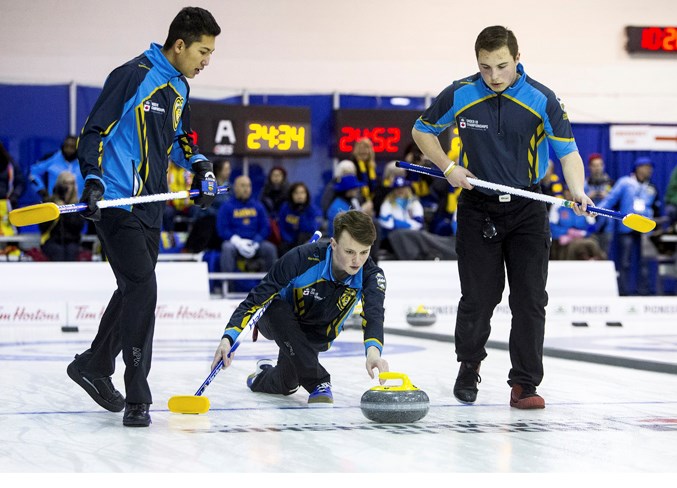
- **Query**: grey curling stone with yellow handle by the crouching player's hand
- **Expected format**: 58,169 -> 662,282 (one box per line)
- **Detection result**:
360,372 -> 430,424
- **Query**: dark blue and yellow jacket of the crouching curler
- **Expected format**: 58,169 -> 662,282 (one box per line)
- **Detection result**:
223,243 -> 386,352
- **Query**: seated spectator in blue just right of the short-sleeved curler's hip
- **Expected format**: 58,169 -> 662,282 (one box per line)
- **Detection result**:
549,188 -> 595,260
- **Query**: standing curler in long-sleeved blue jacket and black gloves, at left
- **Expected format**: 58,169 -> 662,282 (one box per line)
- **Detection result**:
67,7 -> 221,427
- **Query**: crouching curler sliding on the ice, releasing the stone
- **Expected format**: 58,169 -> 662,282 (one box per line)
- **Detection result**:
212,210 -> 388,406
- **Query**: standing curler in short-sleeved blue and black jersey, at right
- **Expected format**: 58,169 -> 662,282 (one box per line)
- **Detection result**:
412,26 -> 592,409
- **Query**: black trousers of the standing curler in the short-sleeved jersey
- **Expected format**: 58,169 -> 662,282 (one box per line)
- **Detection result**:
455,191 -> 550,386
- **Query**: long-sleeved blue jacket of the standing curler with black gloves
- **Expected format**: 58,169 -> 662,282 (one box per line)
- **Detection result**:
78,44 -> 207,228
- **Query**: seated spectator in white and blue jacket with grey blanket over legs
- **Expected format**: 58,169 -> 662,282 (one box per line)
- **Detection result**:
378,176 -> 452,260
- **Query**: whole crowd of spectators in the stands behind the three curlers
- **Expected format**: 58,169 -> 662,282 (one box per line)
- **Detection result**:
0,136 -> 677,295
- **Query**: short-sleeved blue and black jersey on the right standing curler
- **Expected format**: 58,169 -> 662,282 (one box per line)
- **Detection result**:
414,64 -> 578,194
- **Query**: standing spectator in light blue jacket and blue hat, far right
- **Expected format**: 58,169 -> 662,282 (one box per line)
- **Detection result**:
599,157 -> 660,296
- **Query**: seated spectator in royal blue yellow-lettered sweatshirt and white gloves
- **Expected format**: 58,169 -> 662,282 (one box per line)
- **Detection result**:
216,175 -> 277,273
